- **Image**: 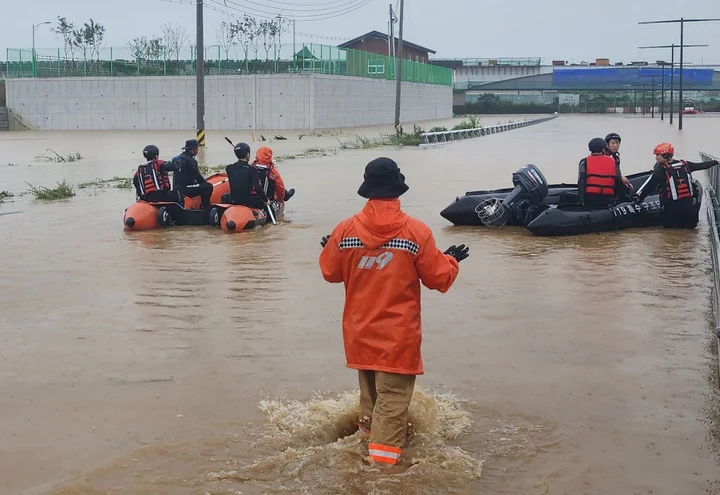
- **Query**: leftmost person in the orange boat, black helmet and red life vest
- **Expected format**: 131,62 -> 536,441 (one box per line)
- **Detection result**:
133,144 -> 182,203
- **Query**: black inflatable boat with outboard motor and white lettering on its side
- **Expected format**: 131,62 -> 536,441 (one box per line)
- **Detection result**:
440,165 -> 703,236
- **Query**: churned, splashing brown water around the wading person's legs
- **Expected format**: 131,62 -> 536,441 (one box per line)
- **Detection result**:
207,388 -> 483,494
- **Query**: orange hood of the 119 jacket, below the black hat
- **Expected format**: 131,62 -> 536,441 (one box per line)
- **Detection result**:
352,199 -> 408,249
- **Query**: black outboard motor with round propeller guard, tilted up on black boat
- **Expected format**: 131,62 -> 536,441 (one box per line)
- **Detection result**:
475,164 -> 548,227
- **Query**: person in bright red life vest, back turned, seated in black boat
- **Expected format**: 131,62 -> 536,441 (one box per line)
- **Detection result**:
578,138 -> 624,207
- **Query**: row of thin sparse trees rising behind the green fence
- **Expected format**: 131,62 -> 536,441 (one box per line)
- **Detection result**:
52,14 -> 289,61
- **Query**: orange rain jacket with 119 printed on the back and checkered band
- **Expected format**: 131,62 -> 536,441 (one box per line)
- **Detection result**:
320,199 -> 458,375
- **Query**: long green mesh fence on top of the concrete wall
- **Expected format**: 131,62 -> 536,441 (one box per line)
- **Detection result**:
5,43 -> 452,86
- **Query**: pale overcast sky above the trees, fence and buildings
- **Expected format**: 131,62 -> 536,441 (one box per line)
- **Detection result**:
5,0 -> 720,64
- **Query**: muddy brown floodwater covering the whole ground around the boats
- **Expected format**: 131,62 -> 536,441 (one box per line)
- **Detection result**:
0,116 -> 720,495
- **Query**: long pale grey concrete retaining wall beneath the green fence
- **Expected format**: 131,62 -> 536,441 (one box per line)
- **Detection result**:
6,74 -> 452,130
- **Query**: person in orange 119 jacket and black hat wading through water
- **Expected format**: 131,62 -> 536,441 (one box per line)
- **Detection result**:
320,158 -> 468,465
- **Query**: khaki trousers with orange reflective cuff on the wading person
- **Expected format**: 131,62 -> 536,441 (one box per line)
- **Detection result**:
359,370 -> 415,464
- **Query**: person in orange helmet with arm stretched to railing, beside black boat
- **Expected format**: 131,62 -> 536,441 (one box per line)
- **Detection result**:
634,143 -> 718,229
